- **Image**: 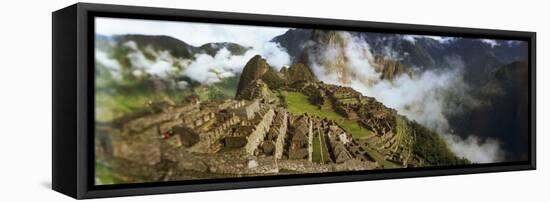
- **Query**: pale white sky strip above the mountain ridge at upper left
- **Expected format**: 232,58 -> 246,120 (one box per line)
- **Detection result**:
95,17 -> 289,46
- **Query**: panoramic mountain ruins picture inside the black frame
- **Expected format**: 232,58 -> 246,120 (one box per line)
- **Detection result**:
94,17 -> 529,185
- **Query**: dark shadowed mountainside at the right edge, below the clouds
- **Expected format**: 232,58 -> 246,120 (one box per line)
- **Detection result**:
451,61 -> 529,161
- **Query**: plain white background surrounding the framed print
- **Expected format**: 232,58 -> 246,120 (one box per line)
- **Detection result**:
0,0 -> 550,202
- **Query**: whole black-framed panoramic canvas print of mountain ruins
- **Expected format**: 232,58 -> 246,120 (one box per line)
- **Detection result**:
52,3 -> 536,198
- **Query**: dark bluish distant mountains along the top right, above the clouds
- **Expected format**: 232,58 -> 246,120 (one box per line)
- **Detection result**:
273,29 -> 527,84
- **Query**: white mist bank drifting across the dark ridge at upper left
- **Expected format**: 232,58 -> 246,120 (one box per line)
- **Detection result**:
95,41 -> 290,85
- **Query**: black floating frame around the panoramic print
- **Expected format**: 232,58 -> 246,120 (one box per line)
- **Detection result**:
52,3 -> 536,199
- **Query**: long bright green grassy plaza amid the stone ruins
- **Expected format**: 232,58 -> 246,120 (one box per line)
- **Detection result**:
281,91 -> 373,139
